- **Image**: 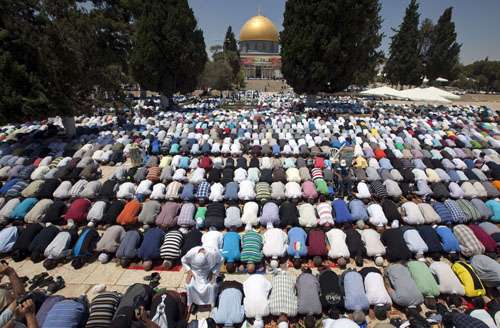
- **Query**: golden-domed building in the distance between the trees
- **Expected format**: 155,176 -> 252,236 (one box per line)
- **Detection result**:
239,15 -> 283,79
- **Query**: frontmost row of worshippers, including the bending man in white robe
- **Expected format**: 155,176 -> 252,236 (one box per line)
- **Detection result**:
4,256 -> 500,328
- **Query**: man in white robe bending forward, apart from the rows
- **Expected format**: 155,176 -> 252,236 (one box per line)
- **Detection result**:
182,246 -> 223,313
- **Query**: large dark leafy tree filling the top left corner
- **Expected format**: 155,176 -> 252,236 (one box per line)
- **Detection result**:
0,0 -> 130,129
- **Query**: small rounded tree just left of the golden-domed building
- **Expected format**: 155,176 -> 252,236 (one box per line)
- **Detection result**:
199,60 -> 233,91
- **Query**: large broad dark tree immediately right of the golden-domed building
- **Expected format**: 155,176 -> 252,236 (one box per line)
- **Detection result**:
280,0 -> 382,93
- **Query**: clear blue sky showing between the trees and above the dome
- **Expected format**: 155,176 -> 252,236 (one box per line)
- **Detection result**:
188,0 -> 500,64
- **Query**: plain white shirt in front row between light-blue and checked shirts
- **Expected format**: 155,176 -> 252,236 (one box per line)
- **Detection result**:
243,274 -> 272,319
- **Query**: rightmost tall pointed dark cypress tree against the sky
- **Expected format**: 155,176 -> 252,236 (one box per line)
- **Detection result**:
427,7 -> 462,80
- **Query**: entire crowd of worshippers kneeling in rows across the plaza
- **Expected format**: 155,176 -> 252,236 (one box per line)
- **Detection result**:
0,97 -> 500,328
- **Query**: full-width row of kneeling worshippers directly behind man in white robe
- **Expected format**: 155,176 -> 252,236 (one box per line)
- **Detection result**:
0,221 -> 500,273
